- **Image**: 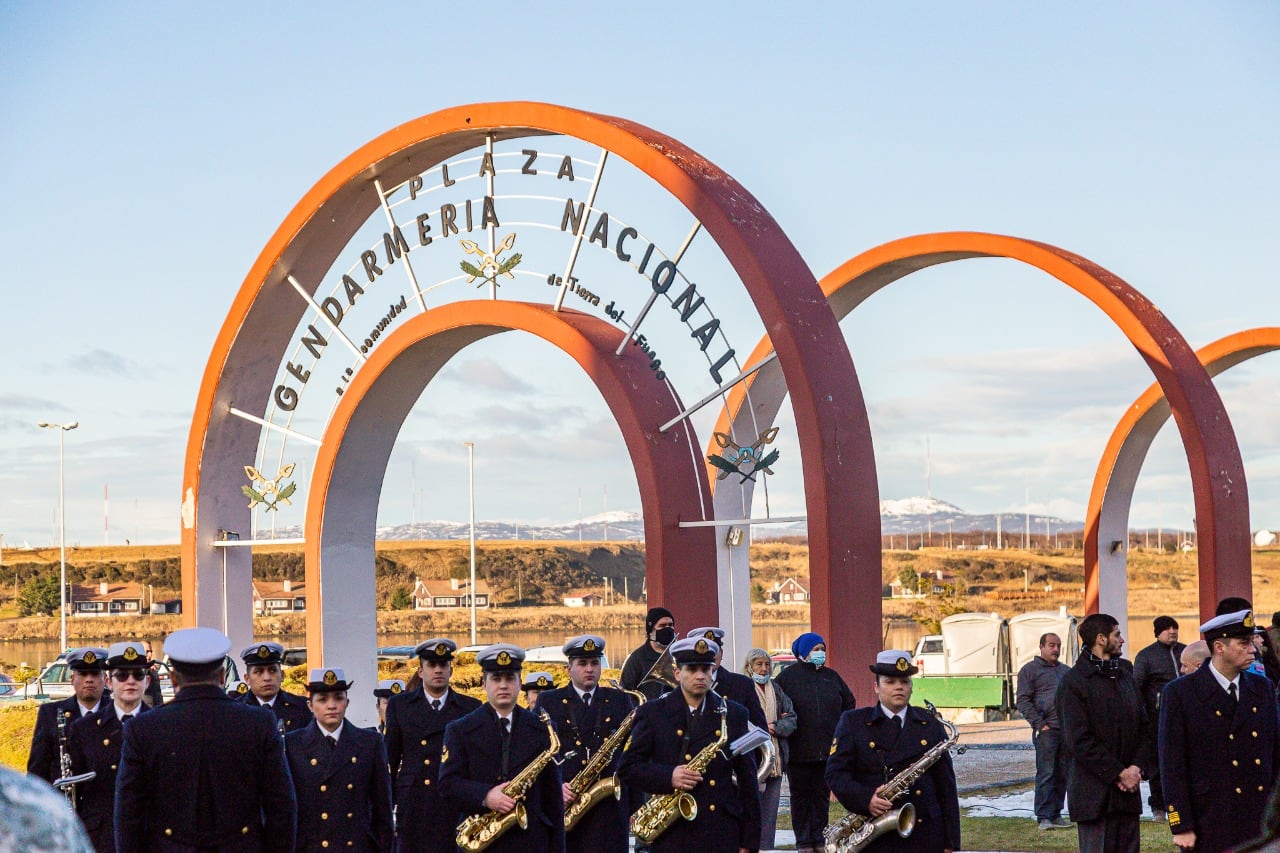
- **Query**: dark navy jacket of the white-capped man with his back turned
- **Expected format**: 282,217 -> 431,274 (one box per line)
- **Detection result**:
115,684 -> 298,853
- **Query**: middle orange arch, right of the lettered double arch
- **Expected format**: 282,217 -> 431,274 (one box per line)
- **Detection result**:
707,232 -> 1252,615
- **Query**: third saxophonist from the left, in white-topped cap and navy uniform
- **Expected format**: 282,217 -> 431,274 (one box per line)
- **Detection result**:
618,637 -> 760,853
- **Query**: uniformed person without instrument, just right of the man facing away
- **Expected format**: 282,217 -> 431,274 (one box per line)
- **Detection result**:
284,666 -> 394,853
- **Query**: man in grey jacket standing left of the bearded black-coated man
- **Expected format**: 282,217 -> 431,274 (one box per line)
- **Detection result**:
1018,634 -> 1071,830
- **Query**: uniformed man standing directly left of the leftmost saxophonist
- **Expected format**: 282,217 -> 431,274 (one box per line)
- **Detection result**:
385,637 -> 480,853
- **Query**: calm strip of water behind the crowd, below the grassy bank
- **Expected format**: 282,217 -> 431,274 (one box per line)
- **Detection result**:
0,615 -> 1196,671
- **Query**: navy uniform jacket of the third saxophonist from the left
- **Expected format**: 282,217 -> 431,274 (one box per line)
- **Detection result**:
620,690 -> 760,853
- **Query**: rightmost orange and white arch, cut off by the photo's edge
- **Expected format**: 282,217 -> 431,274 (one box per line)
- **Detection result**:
1084,327 -> 1280,625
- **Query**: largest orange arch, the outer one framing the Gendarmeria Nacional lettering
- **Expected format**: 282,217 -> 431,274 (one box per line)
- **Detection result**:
182,102 -> 879,712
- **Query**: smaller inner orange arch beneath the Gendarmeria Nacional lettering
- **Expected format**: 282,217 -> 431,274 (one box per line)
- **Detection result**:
306,301 -> 718,721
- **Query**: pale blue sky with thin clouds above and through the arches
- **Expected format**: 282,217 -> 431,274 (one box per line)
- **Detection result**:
0,3 -> 1280,537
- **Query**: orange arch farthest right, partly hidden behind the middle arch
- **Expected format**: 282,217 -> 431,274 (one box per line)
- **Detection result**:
1084,327 -> 1280,619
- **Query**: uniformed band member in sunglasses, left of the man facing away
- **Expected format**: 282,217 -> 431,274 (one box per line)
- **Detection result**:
68,642 -> 150,853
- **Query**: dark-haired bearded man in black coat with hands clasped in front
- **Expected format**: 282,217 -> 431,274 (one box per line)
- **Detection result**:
1057,613 -> 1152,853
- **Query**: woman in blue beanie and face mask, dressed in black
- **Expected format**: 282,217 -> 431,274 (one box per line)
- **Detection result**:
776,631 -> 858,853
